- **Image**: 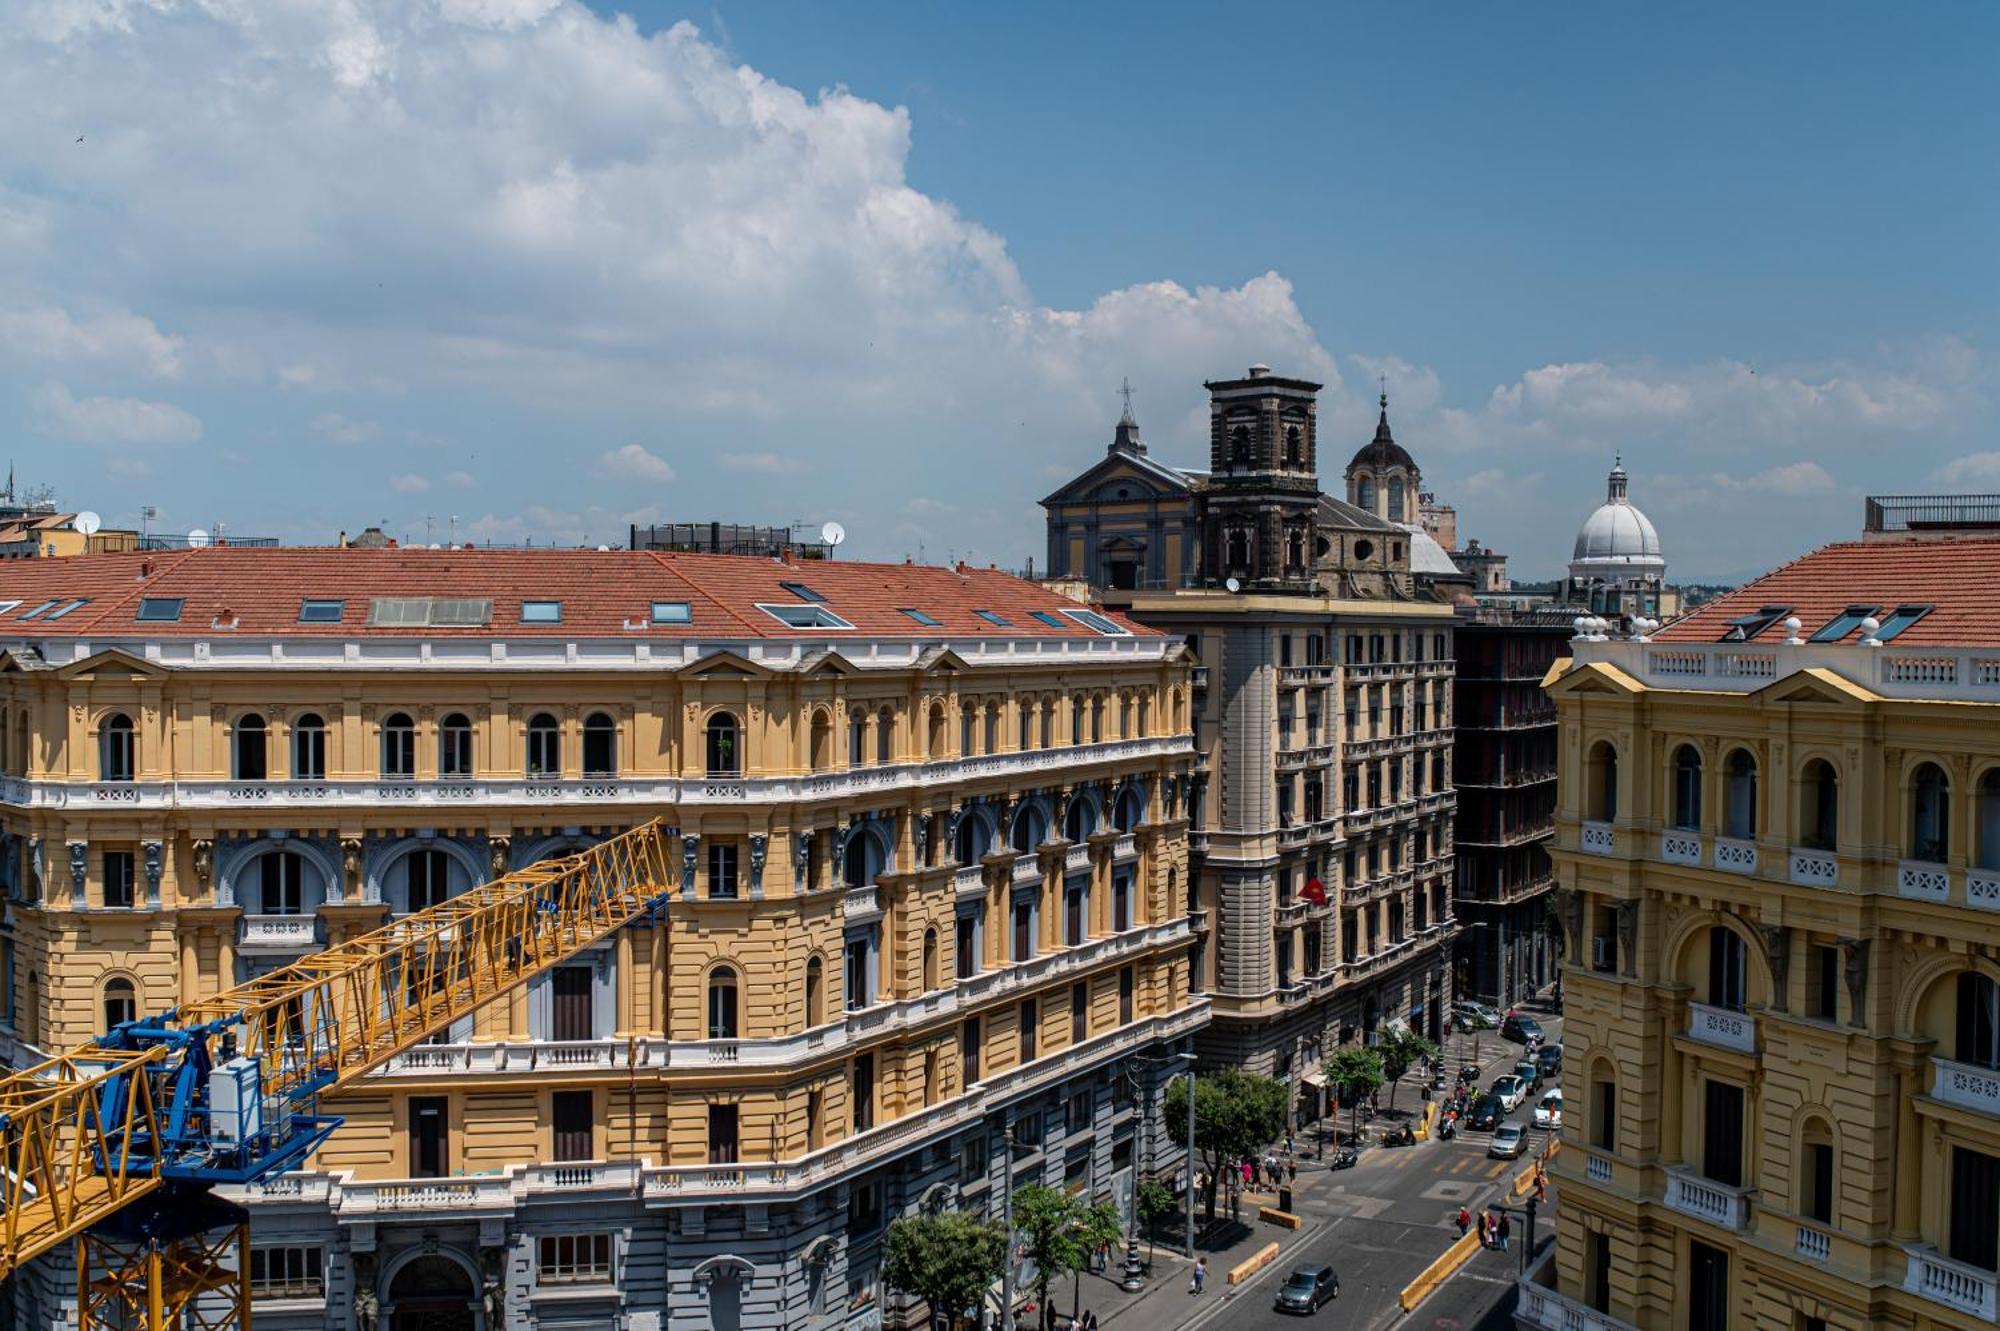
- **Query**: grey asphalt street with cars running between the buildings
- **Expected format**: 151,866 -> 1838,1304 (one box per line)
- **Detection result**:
1112,1007 -> 1562,1331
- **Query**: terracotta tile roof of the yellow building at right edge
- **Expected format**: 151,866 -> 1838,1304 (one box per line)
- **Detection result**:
1654,540 -> 2000,648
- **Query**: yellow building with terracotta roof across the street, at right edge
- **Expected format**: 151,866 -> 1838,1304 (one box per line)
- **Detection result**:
1516,542 -> 2000,1331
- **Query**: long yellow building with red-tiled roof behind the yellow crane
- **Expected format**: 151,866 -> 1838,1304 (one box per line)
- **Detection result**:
0,550 -> 1206,1331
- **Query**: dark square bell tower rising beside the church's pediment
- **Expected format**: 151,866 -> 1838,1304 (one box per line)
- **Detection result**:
1202,366 -> 1320,590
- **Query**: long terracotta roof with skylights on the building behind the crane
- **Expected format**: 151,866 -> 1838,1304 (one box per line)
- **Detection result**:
0,546 -> 1158,642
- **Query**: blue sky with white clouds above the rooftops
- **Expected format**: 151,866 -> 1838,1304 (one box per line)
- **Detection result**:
0,0 -> 2000,578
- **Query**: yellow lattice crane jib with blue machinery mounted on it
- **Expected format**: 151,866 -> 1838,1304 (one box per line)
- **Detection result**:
0,821 -> 674,1279
